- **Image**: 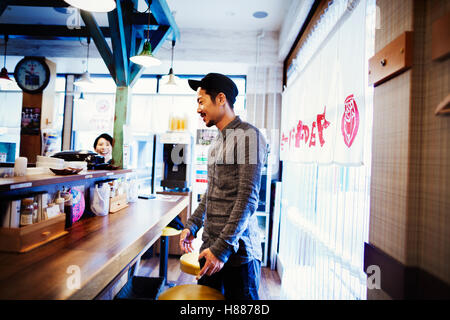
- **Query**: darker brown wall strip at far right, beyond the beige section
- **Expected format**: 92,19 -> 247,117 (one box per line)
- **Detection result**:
415,0 -> 450,284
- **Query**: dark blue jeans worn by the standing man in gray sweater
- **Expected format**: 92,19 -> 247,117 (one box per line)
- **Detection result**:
197,259 -> 261,300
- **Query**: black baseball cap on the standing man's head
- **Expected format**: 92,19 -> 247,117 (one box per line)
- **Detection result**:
188,73 -> 239,105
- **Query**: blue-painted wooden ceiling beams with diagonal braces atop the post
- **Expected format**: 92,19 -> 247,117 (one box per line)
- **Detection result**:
5,0 -> 180,86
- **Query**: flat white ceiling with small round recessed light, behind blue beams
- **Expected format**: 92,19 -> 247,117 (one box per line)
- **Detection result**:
0,0 -> 299,31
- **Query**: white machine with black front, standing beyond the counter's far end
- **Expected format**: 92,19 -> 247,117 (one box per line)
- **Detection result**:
160,132 -> 193,191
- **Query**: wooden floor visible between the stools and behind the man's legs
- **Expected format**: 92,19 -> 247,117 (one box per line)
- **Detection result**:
137,255 -> 281,300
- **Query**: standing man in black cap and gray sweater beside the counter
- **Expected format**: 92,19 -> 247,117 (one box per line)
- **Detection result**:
180,73 -> 267,300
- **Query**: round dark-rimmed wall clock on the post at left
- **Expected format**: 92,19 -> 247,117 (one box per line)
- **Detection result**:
14,57 -> 50,93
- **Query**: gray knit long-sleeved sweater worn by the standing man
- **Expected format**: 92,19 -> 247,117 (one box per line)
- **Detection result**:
186,117 -> 267,266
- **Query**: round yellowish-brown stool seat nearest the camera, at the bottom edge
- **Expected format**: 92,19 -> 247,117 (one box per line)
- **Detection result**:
158,284 -> 225,300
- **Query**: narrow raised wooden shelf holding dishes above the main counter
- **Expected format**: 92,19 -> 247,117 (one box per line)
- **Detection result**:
0,169 -> 133,192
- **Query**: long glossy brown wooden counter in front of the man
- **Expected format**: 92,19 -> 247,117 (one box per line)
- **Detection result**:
0,196 -> 189,299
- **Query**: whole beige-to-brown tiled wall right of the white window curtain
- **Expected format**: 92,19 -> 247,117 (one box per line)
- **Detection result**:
369,0 -> 450,290
